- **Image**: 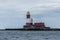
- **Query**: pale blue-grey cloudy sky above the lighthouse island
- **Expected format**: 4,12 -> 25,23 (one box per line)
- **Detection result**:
0,0 -> 60,29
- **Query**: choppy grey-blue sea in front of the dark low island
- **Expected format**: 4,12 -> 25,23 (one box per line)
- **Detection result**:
0,30 -> 60,40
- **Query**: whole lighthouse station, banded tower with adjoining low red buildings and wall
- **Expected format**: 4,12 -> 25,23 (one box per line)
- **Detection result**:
24,11 -> 49,29
